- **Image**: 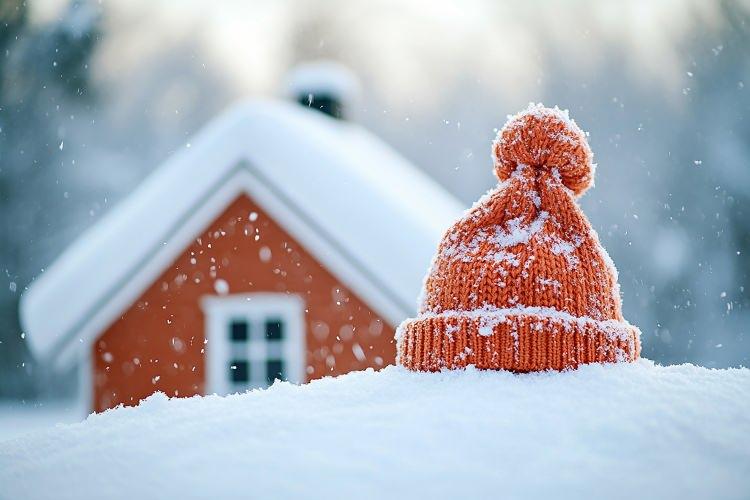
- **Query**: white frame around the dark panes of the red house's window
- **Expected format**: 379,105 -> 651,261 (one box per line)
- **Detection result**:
201,293 -> 305,395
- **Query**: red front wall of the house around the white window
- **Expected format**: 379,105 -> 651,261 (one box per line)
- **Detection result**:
90,192 -> 394,411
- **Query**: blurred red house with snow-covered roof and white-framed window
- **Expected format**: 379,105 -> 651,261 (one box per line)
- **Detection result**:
21,101 -> 461,411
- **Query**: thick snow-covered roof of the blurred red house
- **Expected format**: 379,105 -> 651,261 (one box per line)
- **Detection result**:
20,101 -> 462,368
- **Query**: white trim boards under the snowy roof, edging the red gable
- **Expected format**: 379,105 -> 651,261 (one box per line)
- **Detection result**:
56,161 -> 414,372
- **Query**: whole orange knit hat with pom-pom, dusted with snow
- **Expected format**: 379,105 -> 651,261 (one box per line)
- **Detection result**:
396,104 -> 640,372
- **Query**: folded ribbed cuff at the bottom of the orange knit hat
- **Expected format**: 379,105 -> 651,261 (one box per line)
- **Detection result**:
396,307 -> 641,372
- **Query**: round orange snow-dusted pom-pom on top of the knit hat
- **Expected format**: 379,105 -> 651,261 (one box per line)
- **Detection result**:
492,103 -> 596,196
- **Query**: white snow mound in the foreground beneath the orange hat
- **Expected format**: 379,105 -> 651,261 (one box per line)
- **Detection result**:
0,360 -> 750,499
